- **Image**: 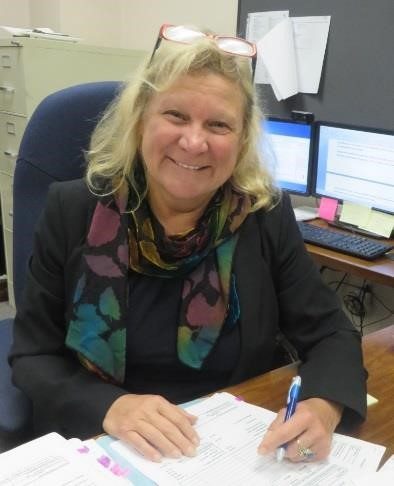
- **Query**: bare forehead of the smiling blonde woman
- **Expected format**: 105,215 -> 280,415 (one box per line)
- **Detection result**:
148,73 -> 245,117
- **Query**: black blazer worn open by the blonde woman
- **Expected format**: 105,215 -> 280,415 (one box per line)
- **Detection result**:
10,180 -> 366,438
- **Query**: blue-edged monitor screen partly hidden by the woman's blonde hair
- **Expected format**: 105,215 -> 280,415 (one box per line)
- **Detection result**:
262,117 -> 313,196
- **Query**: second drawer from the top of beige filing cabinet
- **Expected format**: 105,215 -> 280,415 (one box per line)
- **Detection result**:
0,112 -> 27,175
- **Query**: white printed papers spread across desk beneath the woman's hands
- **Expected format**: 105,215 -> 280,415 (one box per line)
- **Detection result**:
0,393 -> 394,486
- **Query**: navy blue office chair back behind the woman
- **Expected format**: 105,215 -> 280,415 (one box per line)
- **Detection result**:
13,81 -> 120,308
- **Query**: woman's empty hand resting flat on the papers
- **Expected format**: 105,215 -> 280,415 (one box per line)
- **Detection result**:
103,394 -> 199,462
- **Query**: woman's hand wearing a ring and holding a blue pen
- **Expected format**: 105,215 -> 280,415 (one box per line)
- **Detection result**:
258,398 -> 343,462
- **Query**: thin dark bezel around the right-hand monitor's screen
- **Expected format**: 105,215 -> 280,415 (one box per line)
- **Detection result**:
311,120 -> 394,214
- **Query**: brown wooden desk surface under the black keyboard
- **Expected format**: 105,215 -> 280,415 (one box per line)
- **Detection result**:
306,219 -> 394,287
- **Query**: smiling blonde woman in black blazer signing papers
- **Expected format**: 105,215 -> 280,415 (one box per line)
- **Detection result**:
11,26 -> 366,461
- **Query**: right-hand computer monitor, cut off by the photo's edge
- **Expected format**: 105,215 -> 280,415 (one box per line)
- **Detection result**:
313,121 -> 394,214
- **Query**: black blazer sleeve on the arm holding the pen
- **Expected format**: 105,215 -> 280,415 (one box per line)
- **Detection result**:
264,195 -> 367,424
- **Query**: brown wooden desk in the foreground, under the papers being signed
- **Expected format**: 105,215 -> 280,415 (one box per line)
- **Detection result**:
226,325 -> 394,462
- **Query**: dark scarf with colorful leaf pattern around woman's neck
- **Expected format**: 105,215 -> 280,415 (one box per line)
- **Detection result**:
66,178 -> 250,383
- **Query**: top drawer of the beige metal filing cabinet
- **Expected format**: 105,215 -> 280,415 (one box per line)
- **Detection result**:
0,46 -> 26,114
